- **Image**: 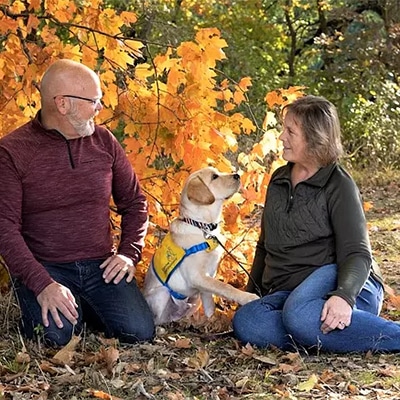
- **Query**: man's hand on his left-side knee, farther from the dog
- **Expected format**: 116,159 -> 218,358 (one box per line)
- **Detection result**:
37,282 -> 79,329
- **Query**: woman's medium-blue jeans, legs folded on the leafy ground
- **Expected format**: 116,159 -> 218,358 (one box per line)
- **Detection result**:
233,264 -> 400,353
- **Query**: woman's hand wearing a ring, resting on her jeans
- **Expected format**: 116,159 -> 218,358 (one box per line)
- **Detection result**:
321,296 -> 353,333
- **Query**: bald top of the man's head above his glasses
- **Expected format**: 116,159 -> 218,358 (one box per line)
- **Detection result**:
40,59 -> 100,108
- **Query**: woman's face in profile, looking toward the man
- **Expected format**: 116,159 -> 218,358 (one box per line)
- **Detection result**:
279,111 -> 310,164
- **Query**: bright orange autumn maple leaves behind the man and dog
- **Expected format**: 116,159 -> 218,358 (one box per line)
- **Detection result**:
0,0 -> 301,286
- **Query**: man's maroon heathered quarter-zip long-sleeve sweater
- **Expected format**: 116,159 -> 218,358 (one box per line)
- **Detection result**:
0,112 -> 147,295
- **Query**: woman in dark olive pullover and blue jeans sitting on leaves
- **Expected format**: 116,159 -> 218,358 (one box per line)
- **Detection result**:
233,96 -> 400,352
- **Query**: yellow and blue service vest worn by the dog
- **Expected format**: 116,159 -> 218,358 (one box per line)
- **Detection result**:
151,233 -> 218,299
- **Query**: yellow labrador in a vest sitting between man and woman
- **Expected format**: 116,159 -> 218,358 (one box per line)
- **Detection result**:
143,167 -> 258,325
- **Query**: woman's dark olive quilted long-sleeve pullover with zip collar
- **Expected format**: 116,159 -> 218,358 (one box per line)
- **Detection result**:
248,163 -> 379,306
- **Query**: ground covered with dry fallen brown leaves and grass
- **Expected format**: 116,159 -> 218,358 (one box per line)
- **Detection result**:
0,170 -> 400,400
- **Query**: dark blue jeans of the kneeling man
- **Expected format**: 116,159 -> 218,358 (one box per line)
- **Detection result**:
14,260 -> 155,345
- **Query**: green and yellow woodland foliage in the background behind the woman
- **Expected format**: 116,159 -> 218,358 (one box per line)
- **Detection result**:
119,0 -> 400,170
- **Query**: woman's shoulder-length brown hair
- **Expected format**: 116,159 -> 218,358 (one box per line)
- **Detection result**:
282,95 -> 343,166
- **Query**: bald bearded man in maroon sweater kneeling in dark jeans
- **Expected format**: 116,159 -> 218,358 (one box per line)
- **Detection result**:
0,60 -> 154,345
